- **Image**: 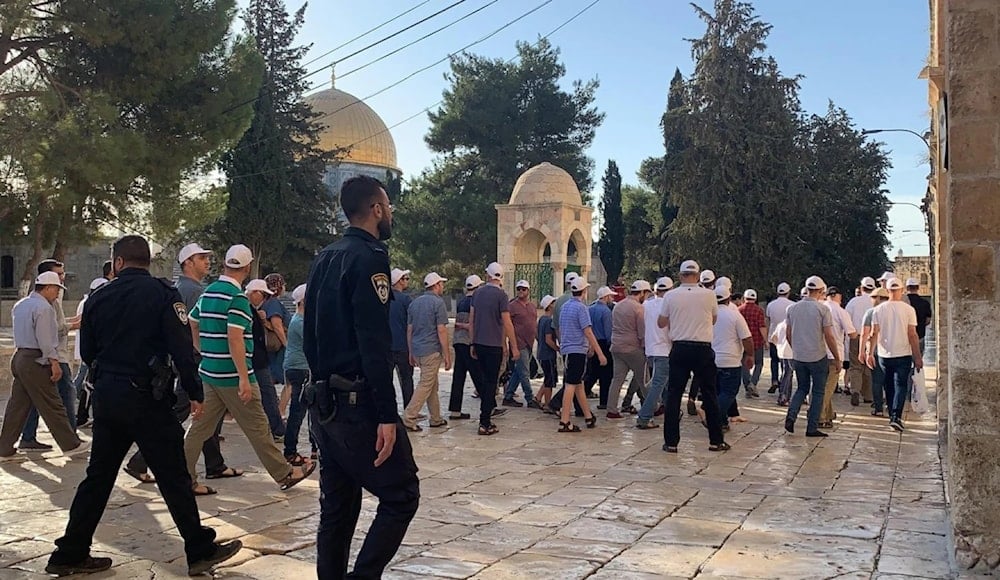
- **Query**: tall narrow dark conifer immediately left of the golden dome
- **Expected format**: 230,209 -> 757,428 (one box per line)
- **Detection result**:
219,0 -> 334,280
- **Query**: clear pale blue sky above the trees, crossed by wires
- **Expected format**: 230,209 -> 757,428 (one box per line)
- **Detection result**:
248,0 -> 929,257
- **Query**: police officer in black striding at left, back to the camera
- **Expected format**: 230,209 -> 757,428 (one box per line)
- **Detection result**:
45,236 -> 242,576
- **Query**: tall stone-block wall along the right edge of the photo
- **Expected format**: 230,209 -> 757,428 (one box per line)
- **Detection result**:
920,0 -> 1000,571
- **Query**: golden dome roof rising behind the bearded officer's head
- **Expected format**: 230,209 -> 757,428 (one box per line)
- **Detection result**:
306,88 -> 399,171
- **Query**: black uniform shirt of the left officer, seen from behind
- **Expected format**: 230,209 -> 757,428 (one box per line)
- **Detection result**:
80,268 -> 205,402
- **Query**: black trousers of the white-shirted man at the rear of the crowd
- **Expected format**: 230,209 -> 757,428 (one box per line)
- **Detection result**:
663,341 -> 724,447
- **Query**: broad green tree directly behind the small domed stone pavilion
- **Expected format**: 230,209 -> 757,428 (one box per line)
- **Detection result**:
392,39 -> 604,276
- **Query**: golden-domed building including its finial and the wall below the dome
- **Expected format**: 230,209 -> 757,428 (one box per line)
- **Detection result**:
305,75 -> 402,224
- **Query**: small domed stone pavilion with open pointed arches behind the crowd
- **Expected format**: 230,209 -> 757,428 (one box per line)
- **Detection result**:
496,162 -> 594,301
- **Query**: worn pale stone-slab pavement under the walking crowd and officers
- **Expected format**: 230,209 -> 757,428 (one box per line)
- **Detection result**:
0,364 -> 955,580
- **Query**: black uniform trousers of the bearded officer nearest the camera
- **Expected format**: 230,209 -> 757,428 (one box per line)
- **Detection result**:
309,393 -> 420,580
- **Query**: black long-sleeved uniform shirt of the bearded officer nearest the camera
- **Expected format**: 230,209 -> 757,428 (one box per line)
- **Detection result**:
303,227 -> 399,423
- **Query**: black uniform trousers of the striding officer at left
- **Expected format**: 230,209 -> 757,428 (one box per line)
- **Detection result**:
49,373 -> 215,564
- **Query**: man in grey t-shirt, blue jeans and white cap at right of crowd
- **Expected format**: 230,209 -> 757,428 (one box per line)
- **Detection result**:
785,276 -> 840,437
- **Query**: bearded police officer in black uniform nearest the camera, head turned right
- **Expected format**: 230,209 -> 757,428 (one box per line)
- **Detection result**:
304,177 -> 420,580
